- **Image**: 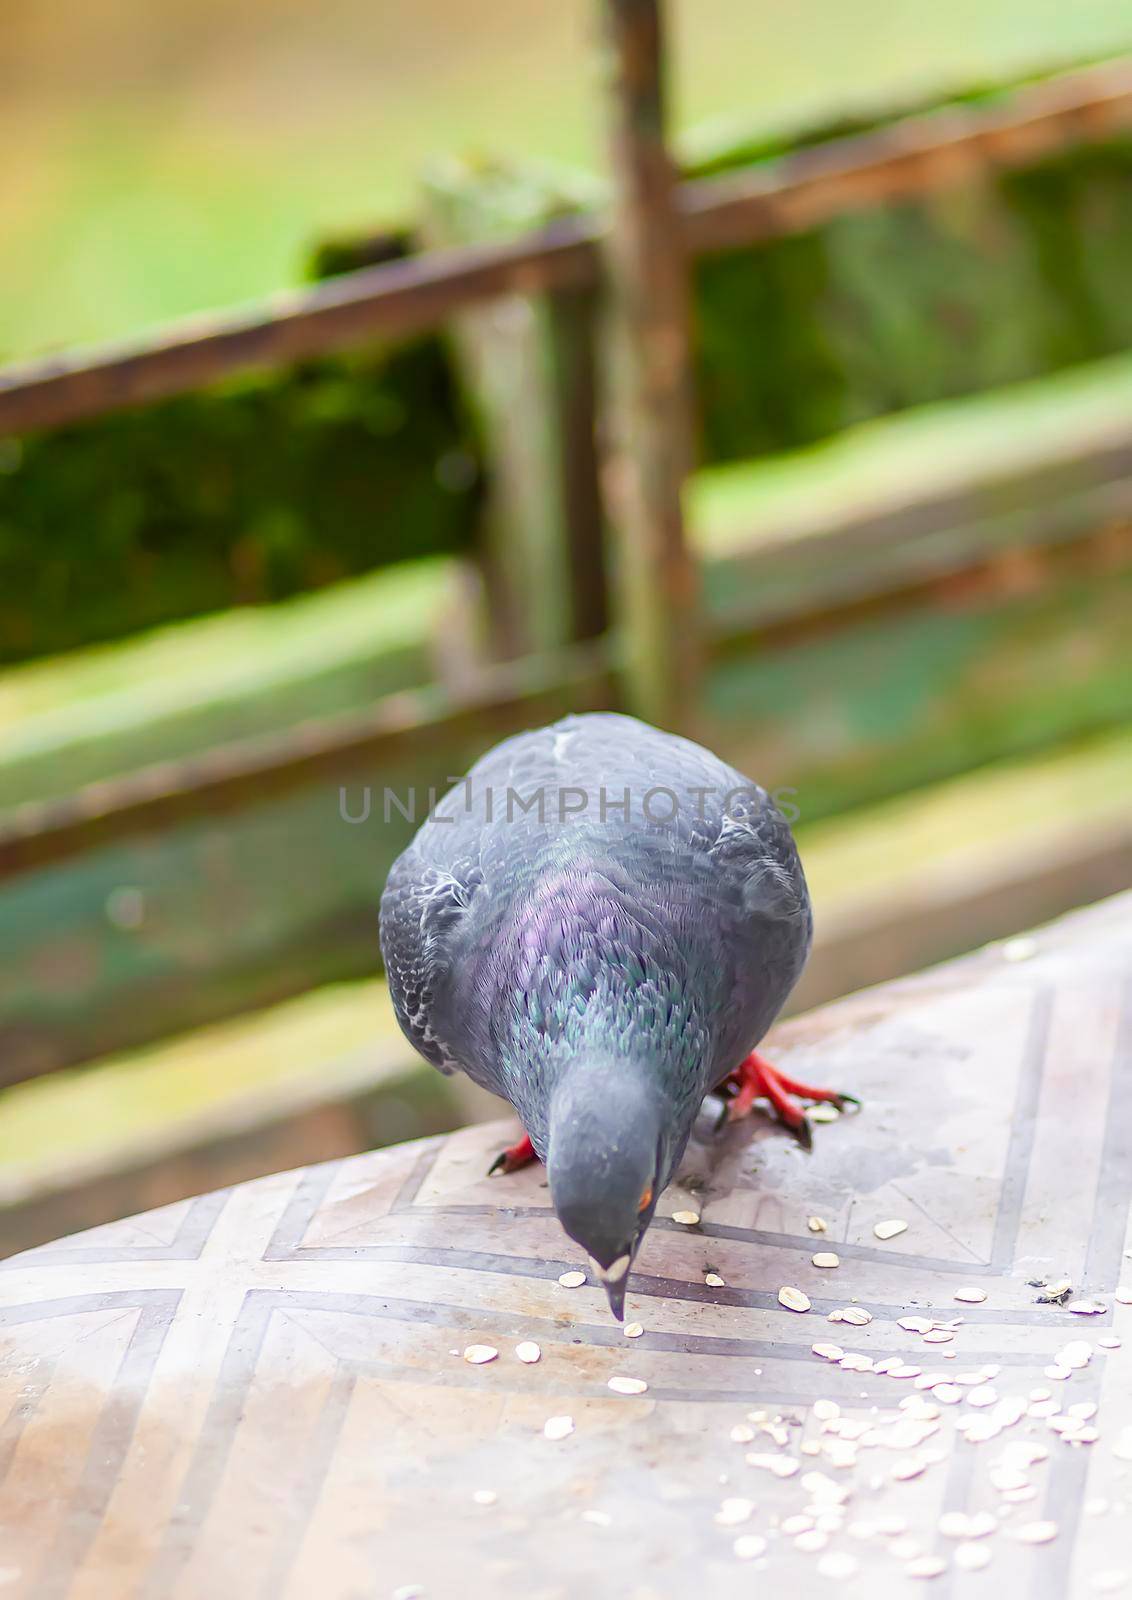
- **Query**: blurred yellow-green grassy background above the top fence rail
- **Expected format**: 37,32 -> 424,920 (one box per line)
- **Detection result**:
8,0 -> 1132,358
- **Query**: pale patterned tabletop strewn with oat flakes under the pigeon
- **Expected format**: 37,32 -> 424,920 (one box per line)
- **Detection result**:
0,898 -> 1132,1600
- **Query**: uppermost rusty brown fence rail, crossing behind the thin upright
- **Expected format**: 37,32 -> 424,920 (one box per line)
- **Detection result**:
0,61 -> 1132,435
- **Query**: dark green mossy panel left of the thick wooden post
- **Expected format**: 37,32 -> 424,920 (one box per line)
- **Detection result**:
0,328 -> 480,661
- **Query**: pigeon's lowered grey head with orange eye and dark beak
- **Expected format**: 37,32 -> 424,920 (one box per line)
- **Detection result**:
547,1059 -> 683,1322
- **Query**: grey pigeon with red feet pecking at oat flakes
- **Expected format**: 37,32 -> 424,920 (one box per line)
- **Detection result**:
381,712 -> 855,1318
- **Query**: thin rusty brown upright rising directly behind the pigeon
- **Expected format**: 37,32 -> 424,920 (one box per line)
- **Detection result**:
601,0 -> 700,728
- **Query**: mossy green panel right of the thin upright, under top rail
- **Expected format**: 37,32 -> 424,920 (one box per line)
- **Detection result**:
696,125 -> 1132,461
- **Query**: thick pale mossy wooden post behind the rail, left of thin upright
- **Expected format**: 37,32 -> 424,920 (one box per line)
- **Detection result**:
422,162 -> 608,659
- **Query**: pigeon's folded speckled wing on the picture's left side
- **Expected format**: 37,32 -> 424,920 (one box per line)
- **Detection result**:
381,846 -> 478,1074
